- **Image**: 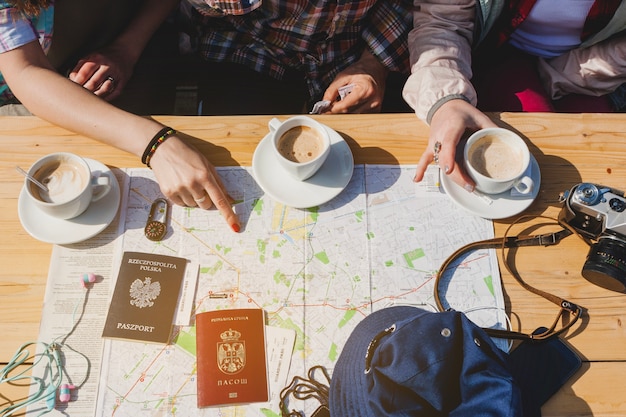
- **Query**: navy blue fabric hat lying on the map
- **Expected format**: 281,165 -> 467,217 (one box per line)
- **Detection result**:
329,306 -> 522,417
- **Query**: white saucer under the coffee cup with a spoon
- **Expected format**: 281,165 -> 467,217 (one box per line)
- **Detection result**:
17,158 -> 120,245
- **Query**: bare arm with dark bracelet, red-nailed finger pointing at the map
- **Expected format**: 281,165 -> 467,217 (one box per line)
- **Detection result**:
0,42 -> 239,231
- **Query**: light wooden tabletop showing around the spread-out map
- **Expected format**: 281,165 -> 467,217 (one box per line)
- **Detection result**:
0,113 -> 626,416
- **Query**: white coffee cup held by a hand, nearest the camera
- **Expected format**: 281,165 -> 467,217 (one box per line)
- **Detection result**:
464,127 -> 534,194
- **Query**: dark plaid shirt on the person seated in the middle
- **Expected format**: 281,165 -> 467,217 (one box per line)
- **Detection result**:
183,0 -> 412,101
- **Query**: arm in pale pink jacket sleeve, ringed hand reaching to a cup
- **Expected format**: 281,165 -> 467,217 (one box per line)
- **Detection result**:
403,0 -> 494,190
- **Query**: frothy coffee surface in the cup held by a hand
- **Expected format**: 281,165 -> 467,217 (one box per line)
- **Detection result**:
468,135 -> 523,180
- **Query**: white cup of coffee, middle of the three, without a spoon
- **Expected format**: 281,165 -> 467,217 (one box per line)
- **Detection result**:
269,116 -> 330,181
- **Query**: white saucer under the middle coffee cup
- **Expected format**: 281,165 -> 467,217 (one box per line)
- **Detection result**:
252,123 -> 354,208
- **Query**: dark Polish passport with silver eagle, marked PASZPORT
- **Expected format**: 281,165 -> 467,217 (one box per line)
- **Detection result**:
102,252 -> 188,343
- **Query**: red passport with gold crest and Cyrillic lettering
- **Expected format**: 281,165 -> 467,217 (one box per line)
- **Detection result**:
196,309 -> 269,408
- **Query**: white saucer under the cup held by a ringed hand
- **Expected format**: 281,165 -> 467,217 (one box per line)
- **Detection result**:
441,155 -> 541,219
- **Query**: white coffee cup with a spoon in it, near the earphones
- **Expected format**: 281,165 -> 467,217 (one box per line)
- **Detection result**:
24,152 -> 111,219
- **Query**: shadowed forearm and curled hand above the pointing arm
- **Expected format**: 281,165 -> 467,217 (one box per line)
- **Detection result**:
69,0 -> 180,100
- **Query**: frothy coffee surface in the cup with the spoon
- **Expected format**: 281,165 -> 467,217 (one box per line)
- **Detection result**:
30,160 -> 89,203
